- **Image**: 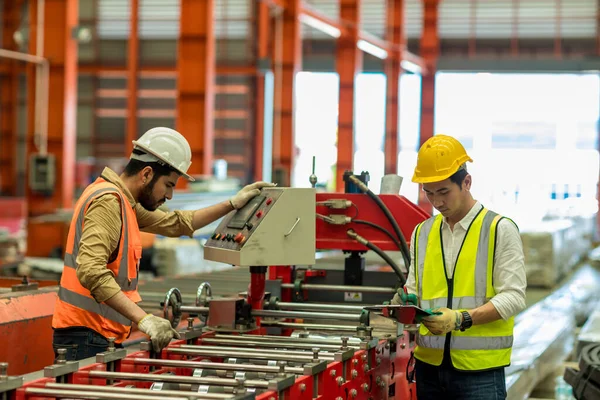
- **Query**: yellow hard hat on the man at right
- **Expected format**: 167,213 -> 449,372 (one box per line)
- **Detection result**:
412,135 -> 473,183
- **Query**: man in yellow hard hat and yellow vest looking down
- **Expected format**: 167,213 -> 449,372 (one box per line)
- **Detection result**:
392,135 -> 526,400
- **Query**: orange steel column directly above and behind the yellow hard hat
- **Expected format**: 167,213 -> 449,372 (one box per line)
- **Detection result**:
419,0 -> 440,214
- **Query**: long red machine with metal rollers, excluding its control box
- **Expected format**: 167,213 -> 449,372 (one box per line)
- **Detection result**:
0,170 -> 428,400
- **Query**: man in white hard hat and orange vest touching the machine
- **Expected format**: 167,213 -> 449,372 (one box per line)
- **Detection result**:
52,127 -> 273,360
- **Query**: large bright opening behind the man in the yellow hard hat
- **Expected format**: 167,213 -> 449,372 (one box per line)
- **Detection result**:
435,73 -> 600,222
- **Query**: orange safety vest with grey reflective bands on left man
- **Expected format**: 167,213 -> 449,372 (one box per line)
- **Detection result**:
52,178 -> 142,343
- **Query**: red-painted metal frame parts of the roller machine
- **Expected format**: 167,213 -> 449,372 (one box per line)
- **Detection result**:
4,193 -> 429,400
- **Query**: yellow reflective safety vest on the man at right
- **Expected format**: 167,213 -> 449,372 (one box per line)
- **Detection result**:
413,207 -> 514,371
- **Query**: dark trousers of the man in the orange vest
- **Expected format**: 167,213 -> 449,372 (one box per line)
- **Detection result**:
52,327 -> 123,362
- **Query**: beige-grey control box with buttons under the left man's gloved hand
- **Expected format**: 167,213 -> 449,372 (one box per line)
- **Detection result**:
204,187 -> 316,266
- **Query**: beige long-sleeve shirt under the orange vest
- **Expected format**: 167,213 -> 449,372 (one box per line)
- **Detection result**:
76,168 -> 194,303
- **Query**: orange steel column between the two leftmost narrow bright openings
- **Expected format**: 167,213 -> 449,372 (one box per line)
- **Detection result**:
335,0 -> 363,192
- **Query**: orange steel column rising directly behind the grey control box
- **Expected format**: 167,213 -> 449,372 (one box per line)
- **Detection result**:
273,0 -> 302,186
